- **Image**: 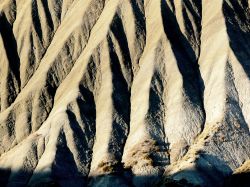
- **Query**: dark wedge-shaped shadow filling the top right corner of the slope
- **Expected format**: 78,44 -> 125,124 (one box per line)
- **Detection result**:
222,0 -> 250,79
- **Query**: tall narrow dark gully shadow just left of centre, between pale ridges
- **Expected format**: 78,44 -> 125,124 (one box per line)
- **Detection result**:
107,30 -> 131,161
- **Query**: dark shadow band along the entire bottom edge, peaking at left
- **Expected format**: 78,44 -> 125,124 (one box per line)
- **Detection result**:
0,160 -> 241,187
